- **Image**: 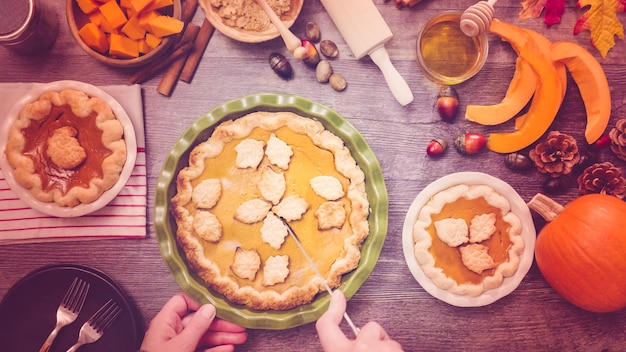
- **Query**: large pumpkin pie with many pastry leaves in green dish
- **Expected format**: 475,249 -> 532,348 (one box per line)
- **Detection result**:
170,112 -> 369,310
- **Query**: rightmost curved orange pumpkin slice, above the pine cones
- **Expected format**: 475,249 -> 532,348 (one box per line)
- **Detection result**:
550,41 -> 611,144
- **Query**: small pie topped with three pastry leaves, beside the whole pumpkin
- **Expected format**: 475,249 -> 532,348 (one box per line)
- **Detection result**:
413,185 -> 524,297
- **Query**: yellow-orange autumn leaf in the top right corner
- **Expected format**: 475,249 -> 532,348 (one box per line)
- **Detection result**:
574,0 -> 626,58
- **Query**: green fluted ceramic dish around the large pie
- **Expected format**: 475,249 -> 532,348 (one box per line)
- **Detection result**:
154,94 -> 389,330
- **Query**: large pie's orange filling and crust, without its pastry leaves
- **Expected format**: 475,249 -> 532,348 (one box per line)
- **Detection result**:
172,113 -> 368,310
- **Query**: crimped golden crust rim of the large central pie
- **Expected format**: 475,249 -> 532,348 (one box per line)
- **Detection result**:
170,111 -> 369,310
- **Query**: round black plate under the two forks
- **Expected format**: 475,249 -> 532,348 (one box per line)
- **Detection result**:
0,265 -> 137,352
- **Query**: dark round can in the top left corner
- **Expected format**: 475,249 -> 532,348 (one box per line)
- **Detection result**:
0,0 -> 59,55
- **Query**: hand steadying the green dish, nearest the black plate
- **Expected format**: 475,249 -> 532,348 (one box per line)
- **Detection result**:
141,292 -> 247,352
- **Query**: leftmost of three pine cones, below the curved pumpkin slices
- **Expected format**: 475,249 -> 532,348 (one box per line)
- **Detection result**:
529,131 -> 580,177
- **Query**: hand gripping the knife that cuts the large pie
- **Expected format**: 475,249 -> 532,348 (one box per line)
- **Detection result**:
315,290 -> 402,352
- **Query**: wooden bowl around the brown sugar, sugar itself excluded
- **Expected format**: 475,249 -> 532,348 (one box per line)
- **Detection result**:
199,0 -> 300,43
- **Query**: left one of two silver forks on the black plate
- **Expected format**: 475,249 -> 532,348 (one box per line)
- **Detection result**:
39,277 -> 89,352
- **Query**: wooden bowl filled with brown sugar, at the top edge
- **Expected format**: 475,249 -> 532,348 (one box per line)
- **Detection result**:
199,0 -> 304,43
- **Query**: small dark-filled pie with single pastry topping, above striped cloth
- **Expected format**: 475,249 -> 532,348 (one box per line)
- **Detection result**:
5,89 -> 126,207
